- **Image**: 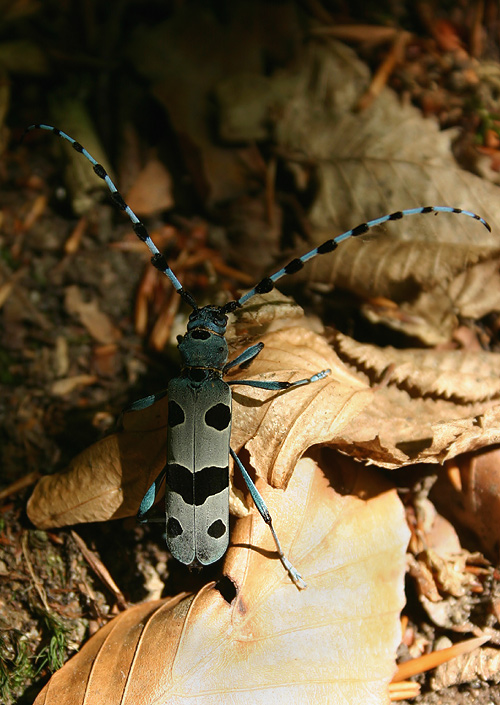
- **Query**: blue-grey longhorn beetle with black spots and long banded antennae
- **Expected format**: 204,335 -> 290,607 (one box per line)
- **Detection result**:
26,125 -> 491,589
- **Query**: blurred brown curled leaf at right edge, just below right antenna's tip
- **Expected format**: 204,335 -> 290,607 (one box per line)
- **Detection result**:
348,242 -> 500,345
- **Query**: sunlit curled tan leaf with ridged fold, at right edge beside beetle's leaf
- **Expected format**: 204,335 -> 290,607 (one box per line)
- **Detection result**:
332,333 -> 500,468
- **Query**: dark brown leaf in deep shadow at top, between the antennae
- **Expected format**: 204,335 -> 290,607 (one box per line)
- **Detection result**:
129,5 -> 268,205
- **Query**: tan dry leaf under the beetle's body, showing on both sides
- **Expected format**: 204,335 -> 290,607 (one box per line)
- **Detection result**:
28,320 -> 372,528
